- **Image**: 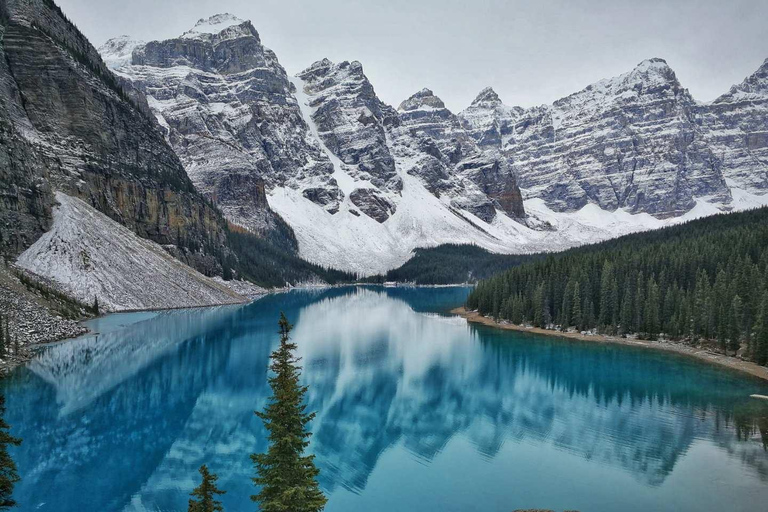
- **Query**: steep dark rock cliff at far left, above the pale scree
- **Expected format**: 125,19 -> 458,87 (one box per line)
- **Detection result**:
0,0 -> 237,273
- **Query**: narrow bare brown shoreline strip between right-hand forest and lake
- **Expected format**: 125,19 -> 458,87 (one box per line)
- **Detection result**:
451,307 -> 768,381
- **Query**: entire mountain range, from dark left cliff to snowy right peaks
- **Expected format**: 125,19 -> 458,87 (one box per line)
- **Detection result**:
0,0 -> 768,307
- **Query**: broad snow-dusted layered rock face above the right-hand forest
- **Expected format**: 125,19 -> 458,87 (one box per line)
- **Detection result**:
462,59 -> 731,217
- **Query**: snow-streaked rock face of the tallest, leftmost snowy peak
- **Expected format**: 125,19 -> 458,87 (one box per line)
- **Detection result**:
101,14 -> 338,232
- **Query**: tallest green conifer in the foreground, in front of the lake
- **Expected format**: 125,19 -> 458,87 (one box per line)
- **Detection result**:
251,313 -> 328,512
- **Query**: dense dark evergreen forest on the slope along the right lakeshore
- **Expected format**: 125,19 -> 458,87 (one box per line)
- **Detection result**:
467,208 -> 768,364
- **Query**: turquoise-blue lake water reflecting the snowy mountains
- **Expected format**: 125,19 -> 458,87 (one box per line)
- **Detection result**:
3,288 -> 768,512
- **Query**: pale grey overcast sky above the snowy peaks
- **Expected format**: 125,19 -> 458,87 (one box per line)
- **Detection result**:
57,0 -> 768,111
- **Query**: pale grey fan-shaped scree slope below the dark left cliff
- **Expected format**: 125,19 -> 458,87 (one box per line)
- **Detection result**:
17,192 -> 247,311
